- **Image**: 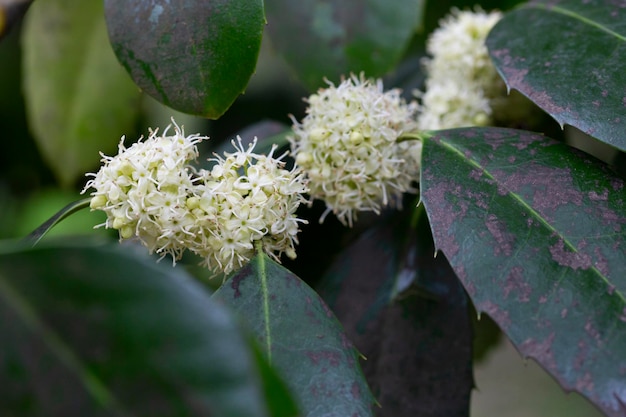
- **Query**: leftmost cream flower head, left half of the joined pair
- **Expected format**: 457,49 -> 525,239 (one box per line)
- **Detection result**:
83,120 -> 206,260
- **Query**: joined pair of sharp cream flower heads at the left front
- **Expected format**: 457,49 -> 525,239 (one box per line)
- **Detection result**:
83,125 -> 307,274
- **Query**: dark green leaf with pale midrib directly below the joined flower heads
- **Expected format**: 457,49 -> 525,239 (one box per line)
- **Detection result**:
213,254 -> 373,417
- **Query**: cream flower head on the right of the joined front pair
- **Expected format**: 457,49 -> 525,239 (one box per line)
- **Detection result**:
192,137 -> 308,273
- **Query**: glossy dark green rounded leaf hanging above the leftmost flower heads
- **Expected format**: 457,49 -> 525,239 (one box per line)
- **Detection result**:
104,0 -> 265,119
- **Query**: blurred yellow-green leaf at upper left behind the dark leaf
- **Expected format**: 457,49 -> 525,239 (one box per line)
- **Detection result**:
23,0 -> 139,187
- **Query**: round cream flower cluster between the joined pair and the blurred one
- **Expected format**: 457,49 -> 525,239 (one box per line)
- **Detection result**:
288,75 -> 421,226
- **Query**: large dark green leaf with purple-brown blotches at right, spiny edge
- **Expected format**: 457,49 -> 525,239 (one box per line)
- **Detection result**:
421,128 -> 626,416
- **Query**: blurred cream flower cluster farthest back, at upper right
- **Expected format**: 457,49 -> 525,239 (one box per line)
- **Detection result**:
418,9 -> 507,130
